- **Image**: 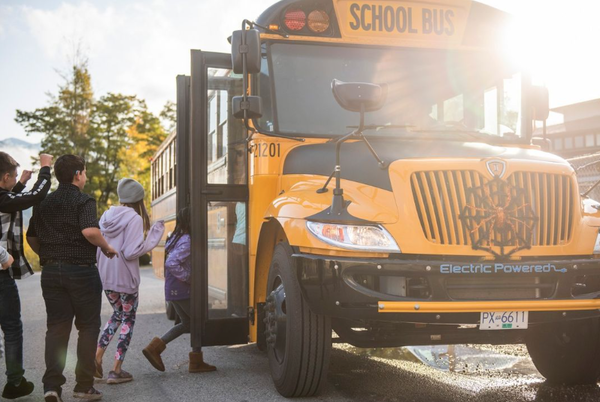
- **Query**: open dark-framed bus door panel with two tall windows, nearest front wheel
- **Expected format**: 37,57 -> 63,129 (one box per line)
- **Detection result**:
189,50 -> 249,347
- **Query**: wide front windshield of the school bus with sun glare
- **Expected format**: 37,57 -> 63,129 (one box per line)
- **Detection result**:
258,42 -> 522,141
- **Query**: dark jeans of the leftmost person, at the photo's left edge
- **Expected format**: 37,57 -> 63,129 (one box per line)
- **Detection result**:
0,271 -> 25,385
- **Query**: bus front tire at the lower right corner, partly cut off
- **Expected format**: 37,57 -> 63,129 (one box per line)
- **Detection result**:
526,318 -> 600,385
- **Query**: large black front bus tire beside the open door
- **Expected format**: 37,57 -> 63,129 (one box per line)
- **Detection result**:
265,243 -> 331,397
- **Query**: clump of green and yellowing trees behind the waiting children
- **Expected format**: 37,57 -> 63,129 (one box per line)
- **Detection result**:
15,60 -> 169,214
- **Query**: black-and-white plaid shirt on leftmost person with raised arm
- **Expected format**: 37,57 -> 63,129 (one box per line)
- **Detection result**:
0,167 -> 50,279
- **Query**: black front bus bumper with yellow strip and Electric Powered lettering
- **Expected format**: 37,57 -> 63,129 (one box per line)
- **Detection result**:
293,253 -> 600,324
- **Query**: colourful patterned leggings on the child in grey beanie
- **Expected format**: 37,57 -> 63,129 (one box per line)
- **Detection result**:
98,290 -> 138,360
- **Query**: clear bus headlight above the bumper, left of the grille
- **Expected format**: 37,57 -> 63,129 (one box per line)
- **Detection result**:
306,221 -> 400,253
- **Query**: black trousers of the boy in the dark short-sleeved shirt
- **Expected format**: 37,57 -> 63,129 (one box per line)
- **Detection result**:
42,263 -> 102,394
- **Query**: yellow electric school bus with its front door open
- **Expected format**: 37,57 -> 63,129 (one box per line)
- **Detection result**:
153,0 -> 600,396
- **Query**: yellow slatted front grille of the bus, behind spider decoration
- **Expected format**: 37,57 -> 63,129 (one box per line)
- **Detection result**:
411,170 -> 575,246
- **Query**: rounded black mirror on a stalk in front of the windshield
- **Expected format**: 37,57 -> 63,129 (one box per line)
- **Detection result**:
331,79 -> 387,112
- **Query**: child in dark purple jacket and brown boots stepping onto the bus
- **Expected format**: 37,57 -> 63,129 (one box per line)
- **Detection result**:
143,207 -> 216,373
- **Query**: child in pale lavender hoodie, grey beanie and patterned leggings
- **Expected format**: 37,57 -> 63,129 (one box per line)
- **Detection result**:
95,179 -> 165,384
